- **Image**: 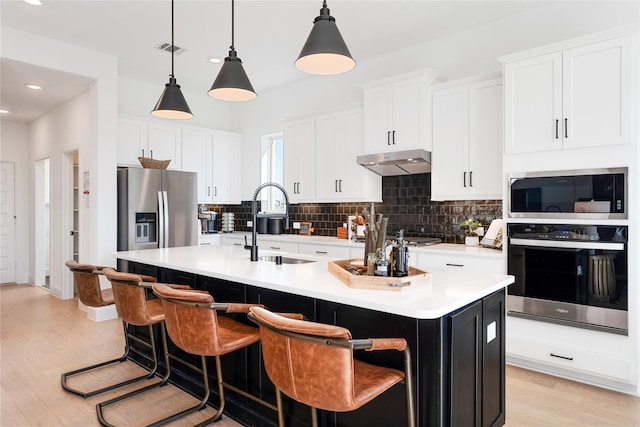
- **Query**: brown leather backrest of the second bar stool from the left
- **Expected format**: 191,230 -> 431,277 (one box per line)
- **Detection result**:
102,267 -> 155,326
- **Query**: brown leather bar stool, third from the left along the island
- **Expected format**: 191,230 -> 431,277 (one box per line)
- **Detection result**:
153,283 -> 277,426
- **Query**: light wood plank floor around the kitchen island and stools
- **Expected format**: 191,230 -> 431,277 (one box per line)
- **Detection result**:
0,285 -> 640,427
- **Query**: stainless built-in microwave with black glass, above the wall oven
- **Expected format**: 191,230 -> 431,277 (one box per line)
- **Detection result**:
507,168 -> 628,219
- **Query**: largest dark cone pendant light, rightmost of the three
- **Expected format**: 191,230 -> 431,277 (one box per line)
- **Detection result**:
295,0 -> 356,76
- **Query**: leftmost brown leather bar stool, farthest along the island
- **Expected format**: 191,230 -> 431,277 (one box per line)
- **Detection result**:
61,260 -> 157,398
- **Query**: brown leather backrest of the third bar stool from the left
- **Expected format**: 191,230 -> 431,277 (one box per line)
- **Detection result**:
153,283 -> 224,356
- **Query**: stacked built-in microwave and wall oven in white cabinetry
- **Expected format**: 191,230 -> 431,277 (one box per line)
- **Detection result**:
506,168 -> 630,335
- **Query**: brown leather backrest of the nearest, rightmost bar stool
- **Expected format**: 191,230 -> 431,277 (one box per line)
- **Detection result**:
250,307 -> 359,412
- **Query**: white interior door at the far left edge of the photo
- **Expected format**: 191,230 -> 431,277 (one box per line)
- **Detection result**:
0,162 -> 16,283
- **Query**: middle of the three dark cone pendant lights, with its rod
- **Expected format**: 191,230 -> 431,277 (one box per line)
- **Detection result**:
209,0 -> 258,101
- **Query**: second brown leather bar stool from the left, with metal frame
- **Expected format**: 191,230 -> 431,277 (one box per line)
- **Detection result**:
96,267 -> 189,426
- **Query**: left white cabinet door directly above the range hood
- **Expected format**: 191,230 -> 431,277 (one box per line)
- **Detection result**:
364,85 -> 393,154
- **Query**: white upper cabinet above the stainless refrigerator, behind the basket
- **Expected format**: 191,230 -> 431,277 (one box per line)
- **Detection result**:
117,116 -> 182,170
